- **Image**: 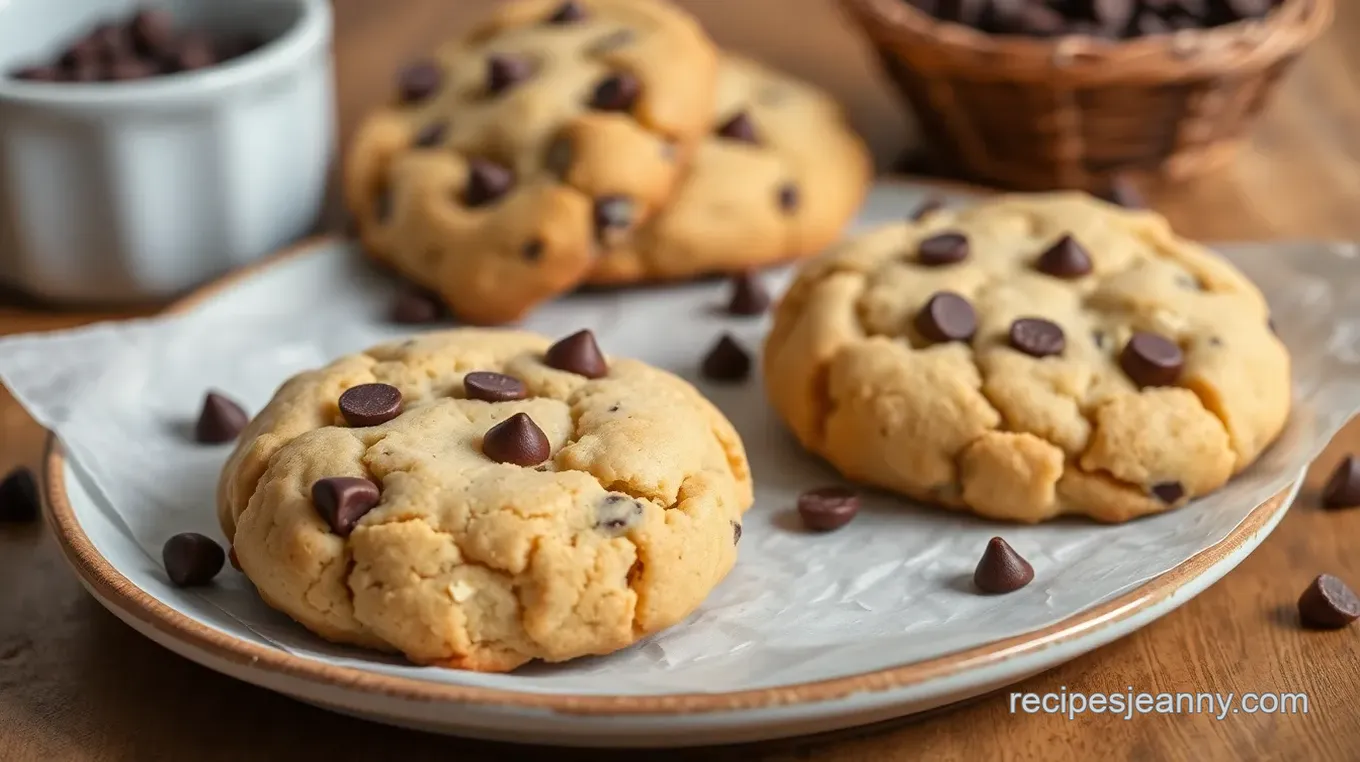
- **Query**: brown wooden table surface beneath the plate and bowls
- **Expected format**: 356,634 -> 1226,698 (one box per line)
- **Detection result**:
0,0 -> 1360,762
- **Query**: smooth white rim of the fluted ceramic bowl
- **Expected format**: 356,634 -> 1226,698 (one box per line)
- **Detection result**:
0,0 -> 333,112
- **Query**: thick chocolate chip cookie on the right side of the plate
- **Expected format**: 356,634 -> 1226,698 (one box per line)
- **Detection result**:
764,193 -> 1291,523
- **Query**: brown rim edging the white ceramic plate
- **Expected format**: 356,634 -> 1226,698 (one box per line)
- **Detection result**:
42,180 -> 1291,714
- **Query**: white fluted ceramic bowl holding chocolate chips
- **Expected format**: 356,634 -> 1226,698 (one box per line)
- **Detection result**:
0,0 -> 335,302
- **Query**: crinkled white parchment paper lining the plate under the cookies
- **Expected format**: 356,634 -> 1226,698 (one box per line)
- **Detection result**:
0,188 -> 1360,694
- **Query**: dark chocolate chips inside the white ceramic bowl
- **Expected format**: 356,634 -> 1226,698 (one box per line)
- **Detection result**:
10,8 -> 261,83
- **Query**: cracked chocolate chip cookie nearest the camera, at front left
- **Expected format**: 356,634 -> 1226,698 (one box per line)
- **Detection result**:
218,329 -> 752,671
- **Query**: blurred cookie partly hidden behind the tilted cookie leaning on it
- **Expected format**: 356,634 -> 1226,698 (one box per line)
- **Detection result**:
589,56 -> 872,283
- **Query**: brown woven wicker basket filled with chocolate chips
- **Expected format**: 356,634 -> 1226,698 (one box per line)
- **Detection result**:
840,0 -> 1333,192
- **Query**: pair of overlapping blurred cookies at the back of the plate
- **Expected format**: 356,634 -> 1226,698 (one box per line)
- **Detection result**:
345,0 -> 872,324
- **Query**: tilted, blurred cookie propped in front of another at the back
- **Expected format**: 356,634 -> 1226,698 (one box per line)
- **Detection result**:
345,0 -> 717,324
